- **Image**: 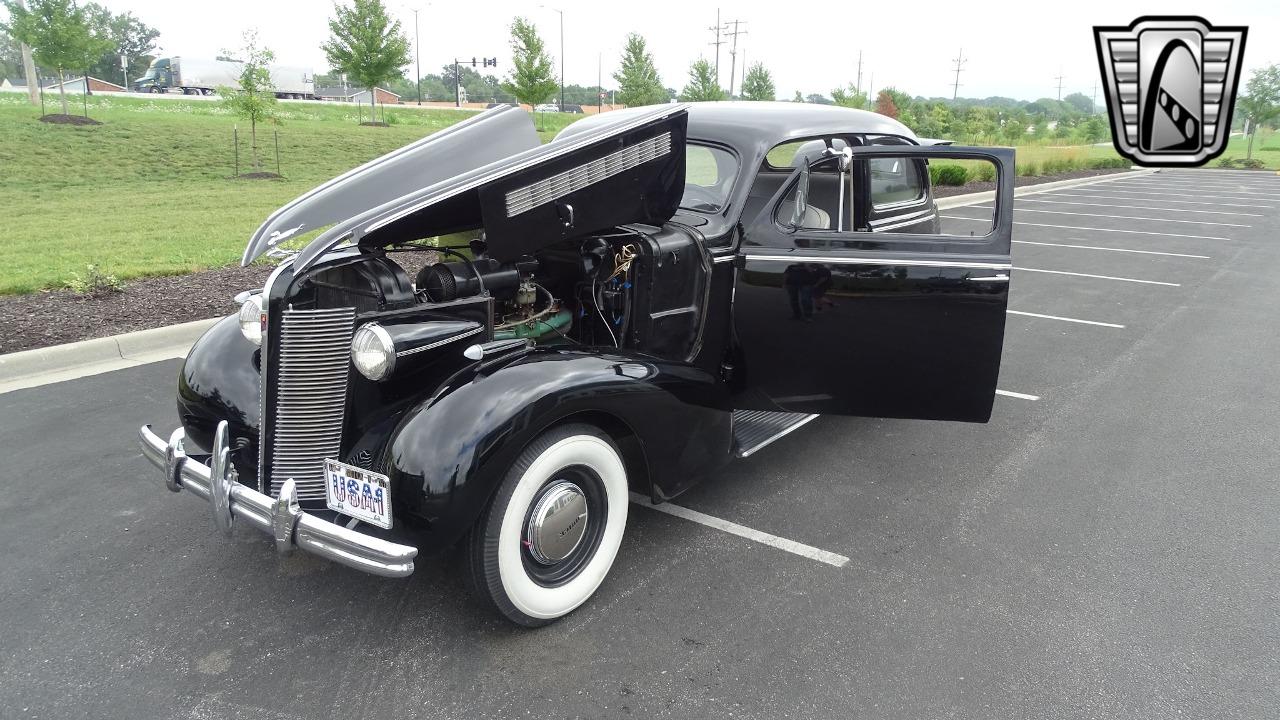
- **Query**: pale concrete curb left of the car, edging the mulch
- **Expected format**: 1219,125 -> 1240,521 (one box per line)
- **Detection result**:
0,318 -> 221,393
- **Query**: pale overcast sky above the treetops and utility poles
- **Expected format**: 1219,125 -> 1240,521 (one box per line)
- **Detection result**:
85,0 -> 1280,102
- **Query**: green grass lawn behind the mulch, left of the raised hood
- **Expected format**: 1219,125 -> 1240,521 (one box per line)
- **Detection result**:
0,94 -> 581,295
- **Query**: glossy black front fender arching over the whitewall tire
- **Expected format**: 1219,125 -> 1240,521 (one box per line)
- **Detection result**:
384,350 -> 732,544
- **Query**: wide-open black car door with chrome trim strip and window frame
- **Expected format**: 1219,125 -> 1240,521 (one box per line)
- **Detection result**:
732,146 -> 1014,423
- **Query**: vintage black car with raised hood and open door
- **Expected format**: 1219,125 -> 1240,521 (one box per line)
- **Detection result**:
140,102 -> 1014,625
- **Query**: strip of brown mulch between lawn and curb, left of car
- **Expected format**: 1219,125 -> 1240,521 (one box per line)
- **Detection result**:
0,265 -> 271,354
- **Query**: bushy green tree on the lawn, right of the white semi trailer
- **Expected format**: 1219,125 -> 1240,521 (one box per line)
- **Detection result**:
320,0 -> 410,121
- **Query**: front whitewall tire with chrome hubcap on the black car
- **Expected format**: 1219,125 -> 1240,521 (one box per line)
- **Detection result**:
467,424 -> 628,626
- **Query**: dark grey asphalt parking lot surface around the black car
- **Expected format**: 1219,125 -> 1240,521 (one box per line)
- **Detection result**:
0,170 -> 1280,719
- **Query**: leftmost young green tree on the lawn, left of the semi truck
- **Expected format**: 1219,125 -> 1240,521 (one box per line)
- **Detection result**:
0,0 -> 110,115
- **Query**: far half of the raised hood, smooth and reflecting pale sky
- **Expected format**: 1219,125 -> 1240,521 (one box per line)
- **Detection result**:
241,105 -> 540,265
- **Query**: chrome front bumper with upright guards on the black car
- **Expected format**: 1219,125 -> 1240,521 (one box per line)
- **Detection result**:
138,420 -> 417,578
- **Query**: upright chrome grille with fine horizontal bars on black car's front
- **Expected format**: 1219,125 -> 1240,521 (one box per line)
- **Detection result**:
264,307 -> 356,500
